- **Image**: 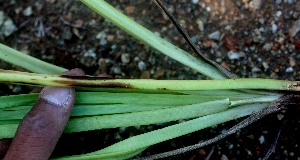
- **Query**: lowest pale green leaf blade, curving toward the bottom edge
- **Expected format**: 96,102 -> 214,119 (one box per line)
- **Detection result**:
54,104 -> 268,160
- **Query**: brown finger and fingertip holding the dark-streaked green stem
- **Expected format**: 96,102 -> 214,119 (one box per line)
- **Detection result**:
4,69 -> 84,160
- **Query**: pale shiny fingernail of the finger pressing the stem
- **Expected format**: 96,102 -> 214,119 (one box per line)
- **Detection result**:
40,87 -> 72,106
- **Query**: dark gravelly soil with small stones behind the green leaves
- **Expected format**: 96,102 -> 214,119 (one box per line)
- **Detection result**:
0,0 -> 300,160
